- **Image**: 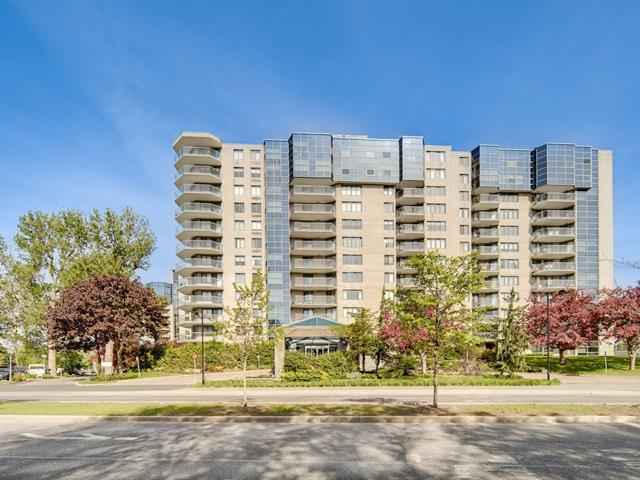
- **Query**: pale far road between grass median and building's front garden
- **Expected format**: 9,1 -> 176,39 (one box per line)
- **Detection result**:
0,375 -> 640,404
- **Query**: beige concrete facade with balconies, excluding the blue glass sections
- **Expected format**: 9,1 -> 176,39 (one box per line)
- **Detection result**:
174,132 -> 613,352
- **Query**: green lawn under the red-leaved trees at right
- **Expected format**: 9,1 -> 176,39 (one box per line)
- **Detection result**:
527,355 -> 640,376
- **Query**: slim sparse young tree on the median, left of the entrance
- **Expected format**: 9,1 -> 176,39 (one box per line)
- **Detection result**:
221,271 -> 269,407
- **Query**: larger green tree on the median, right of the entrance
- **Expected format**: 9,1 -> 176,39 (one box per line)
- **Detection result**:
396,252 -> 483,408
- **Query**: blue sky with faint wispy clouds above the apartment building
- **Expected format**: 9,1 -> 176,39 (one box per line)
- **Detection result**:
0,0 -> 640,285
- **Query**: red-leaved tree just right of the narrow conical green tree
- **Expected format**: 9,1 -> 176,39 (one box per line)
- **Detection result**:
526,290 -> 598,364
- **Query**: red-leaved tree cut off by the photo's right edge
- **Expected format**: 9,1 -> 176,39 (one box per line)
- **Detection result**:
598,284 -> 640,370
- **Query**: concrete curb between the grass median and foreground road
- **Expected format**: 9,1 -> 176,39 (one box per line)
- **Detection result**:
0,415 -> 640,425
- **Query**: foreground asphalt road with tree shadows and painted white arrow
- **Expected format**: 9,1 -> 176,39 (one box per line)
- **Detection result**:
0,417 -> 640,480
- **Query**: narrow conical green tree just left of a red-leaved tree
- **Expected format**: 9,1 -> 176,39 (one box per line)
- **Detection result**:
495,288 -> 529,376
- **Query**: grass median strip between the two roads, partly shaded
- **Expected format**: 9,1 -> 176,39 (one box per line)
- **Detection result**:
0,402 -> 640,417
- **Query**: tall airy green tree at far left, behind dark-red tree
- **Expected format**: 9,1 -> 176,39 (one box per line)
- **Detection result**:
15,210 -> 88,375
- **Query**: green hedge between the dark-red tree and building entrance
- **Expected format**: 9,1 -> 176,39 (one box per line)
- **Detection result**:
154,341 -> 274,372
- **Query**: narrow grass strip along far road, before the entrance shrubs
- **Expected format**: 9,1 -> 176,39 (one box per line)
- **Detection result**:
197,375 -> 560,388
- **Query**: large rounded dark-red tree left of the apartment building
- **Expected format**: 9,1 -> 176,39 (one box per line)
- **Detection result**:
47,275 -> 166,369
